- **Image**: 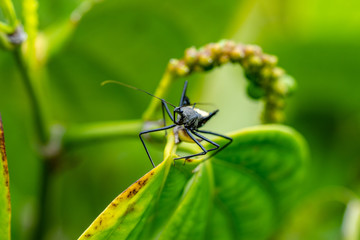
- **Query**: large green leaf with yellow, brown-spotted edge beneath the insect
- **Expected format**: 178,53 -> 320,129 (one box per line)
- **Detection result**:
80,125 -> 307,239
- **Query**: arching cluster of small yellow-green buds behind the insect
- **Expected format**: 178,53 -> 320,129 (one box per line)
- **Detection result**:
168,40 -> 296,123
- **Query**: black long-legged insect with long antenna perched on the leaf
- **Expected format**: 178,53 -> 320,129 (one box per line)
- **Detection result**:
103,80 -> 232,167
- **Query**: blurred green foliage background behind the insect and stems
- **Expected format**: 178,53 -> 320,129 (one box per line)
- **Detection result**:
0,0 -> 360,239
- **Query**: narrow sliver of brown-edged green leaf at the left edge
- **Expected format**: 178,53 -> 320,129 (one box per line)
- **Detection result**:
0,117 -> 11,240
